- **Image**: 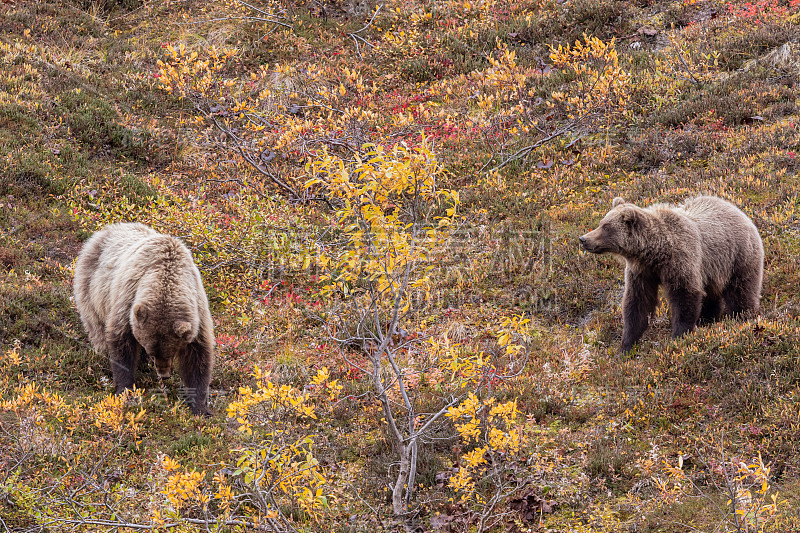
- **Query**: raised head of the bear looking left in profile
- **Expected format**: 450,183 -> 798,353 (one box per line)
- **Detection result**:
578,197 -> 646,257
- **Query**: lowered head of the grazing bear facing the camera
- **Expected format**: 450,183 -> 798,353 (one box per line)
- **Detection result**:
131,302 -> 199,378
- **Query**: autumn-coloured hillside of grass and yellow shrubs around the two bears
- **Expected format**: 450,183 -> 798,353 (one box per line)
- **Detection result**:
0,0 -> 800,532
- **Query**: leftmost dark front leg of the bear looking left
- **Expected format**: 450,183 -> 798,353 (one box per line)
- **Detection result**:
622,265 -> 658,353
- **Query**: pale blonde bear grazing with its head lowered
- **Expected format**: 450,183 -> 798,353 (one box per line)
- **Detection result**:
73,224 -> 214,415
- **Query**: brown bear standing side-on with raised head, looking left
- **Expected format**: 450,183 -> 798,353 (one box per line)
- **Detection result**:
580,196 -> 764,352
